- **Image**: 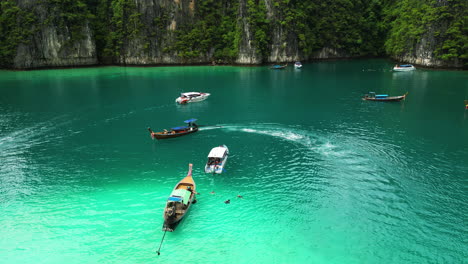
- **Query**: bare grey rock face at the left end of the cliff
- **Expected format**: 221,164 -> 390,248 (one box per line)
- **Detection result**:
13,0 -> 98,69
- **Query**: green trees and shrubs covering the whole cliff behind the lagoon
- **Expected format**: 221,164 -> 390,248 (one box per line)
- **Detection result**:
0,0 -> 468,67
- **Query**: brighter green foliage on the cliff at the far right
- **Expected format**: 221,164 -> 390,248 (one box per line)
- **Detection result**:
385,0 -> 468,60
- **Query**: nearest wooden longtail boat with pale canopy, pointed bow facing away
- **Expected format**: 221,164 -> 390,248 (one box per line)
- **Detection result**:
162,164 -> 197,232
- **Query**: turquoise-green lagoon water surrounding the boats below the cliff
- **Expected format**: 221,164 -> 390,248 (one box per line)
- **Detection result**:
0,60 -> 468,264
